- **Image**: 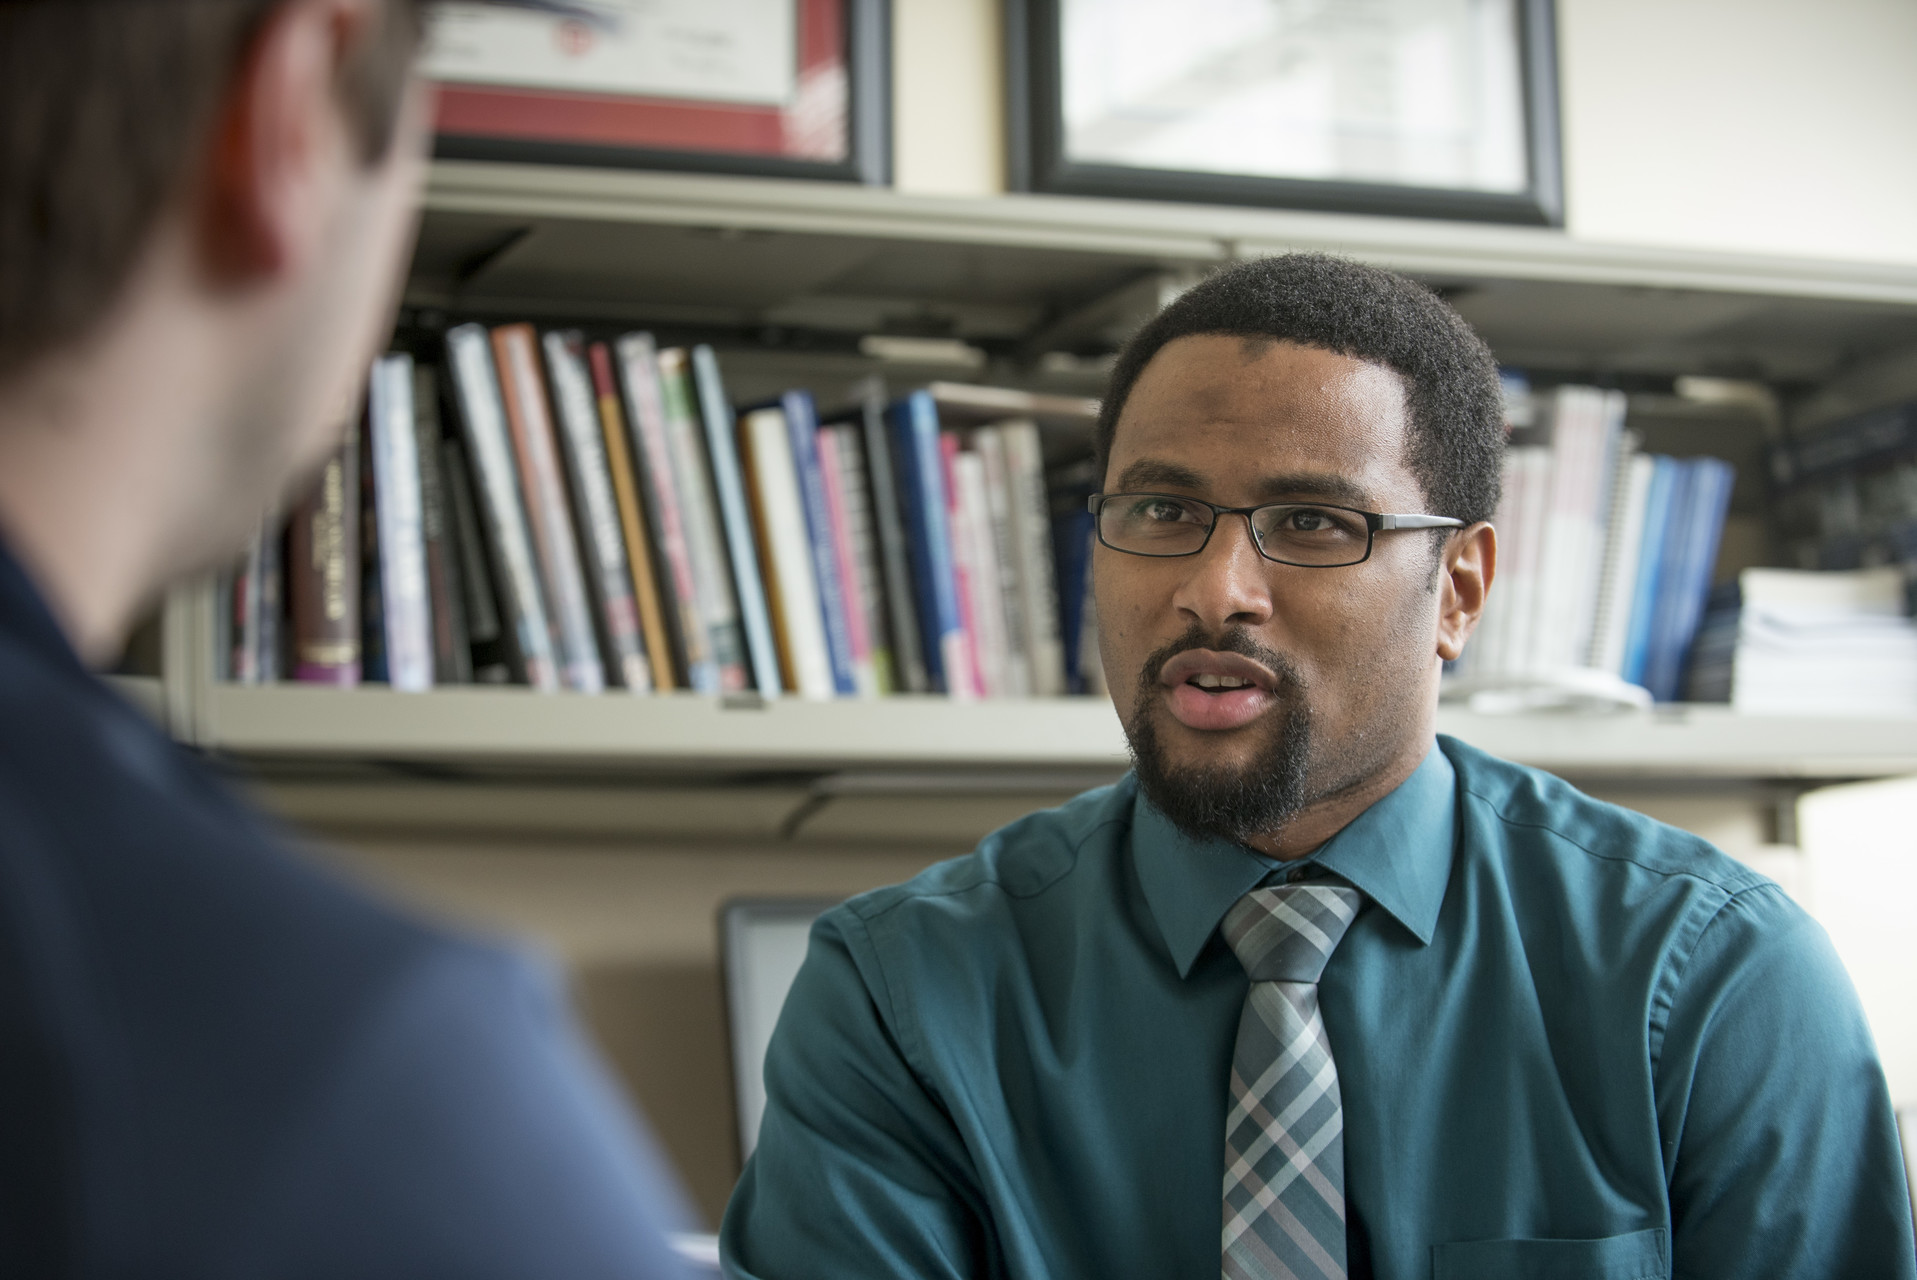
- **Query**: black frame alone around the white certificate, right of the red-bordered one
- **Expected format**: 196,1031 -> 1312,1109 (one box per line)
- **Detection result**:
1005,0 -> 1564,226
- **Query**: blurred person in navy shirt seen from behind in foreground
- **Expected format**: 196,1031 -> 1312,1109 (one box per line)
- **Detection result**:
0,0 -> 684,1280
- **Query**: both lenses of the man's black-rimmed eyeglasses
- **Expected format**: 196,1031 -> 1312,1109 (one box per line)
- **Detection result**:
1098,494 -> 1371,565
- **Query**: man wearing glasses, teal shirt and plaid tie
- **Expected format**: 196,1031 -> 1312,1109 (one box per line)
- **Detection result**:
725,255 -> 1917,1280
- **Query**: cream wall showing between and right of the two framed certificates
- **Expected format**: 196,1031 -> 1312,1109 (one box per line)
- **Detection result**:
893,0 -> 1917,263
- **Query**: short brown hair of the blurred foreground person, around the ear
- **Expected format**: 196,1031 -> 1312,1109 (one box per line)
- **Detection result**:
0,0 -> 420,379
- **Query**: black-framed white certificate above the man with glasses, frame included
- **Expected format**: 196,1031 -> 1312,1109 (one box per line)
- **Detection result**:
1006,0 -> 1562,226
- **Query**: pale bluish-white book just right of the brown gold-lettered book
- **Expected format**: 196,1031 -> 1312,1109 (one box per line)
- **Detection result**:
366,354 -> 433,694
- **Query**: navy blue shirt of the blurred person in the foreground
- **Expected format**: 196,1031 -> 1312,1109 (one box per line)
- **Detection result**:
0,550 -> 682,1280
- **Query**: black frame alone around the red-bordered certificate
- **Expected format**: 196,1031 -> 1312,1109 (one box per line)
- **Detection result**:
433,0 -> 891,186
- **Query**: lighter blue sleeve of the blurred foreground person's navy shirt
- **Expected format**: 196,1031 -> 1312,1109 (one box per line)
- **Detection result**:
241,941 -> 688,1280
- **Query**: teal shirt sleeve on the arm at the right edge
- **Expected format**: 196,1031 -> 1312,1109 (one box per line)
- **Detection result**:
1656,885 -> 1917,1280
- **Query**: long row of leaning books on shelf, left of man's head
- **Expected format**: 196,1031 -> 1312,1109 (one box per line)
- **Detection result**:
220,324 -> 1097,699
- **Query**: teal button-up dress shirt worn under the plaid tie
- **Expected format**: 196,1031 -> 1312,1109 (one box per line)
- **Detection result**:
723,738 -> 1917,1280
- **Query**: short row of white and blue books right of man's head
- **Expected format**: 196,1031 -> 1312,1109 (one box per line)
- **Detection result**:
1451,379 -> 1735,703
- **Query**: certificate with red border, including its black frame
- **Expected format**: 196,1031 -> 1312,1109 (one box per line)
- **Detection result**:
424,0 -> 891,184
